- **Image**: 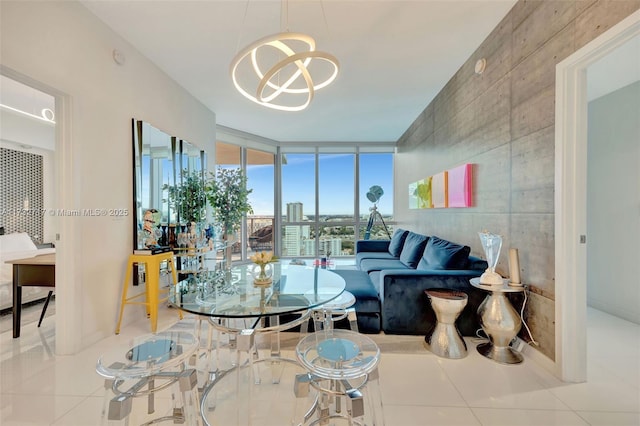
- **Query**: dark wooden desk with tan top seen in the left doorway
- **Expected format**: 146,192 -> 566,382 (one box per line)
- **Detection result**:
5,253 -> 56,339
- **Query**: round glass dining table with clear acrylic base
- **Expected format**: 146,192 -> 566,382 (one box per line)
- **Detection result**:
169,263 -> 345,425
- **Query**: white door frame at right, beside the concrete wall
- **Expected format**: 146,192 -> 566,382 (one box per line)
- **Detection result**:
555,10 -> 640,382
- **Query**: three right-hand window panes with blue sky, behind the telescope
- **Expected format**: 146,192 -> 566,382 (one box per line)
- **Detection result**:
281,145 -> 393,257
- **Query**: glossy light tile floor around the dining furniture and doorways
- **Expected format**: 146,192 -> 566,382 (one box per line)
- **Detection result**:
0,309 -> 640,426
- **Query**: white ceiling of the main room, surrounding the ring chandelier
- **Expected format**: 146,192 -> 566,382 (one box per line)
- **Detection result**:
81,0 -> 515,142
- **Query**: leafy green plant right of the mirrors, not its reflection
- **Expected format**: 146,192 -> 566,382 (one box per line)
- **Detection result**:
205,167 -> 253,240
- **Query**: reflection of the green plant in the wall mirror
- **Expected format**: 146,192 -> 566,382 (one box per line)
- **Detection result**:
163,169 -> 207,223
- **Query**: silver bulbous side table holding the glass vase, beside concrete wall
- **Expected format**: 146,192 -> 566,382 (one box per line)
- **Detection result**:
470,278 -> 525,364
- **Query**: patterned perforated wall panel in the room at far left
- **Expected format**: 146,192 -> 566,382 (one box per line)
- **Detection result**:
0,148 -> 44,242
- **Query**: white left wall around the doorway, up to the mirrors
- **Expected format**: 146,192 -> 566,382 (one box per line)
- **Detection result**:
0,1 -> 215,349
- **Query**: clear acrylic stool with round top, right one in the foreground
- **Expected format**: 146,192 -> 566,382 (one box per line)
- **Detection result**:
294,330 -> 384,426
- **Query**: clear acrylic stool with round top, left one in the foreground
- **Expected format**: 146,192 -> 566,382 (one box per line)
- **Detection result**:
96,331 -> 202,425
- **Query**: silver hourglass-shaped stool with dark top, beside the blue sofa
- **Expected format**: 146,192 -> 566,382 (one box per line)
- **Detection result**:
425,289 -> 468,359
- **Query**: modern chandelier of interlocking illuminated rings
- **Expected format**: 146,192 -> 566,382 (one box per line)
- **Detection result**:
230,2 -> 339,111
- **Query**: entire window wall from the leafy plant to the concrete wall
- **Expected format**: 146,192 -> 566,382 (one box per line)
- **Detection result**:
216,133 -> 394,260
